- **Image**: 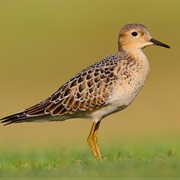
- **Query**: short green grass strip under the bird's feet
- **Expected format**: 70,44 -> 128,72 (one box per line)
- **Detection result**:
0,143 -> 180,179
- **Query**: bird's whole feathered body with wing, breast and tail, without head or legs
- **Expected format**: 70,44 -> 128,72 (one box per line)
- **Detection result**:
2,52 -> 149,124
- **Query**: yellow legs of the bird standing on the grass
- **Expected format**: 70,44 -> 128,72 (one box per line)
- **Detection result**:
87,121 -> 102,160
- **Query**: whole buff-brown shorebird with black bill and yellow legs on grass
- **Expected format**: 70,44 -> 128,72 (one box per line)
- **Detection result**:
0,23 -> 170,160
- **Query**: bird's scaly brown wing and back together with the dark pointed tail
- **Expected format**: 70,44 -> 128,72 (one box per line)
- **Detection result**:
0,54 -> 120,125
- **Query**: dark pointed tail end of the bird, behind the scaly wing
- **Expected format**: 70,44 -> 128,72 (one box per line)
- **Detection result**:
0,99 -> 50,126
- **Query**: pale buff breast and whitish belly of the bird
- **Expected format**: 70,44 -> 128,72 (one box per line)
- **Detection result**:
85,59 -> 150,122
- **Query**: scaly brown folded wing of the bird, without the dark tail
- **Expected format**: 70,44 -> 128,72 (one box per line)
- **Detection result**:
46,53 -> 118,115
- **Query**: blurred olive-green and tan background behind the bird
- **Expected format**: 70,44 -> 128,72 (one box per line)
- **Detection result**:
0,1 -> 180,151
